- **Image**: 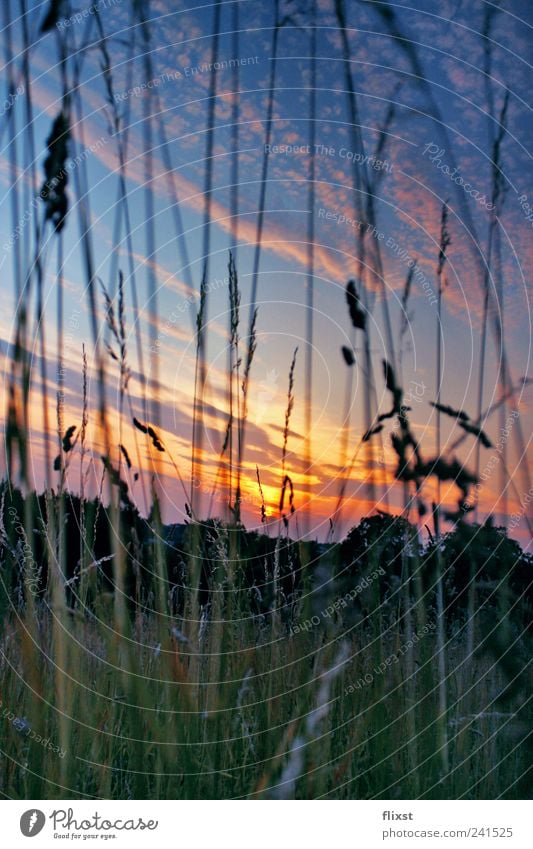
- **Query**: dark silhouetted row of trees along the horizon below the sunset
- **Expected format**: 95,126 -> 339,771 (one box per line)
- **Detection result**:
1,488 -> 533,627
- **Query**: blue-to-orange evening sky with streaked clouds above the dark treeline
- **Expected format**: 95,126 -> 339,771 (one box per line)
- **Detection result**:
0,0 -> 533,543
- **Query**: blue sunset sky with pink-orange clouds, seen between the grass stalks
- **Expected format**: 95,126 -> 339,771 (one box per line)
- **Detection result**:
0,0 -> 533,534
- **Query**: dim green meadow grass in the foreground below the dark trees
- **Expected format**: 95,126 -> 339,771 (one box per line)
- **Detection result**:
0,510 -> 531,799
